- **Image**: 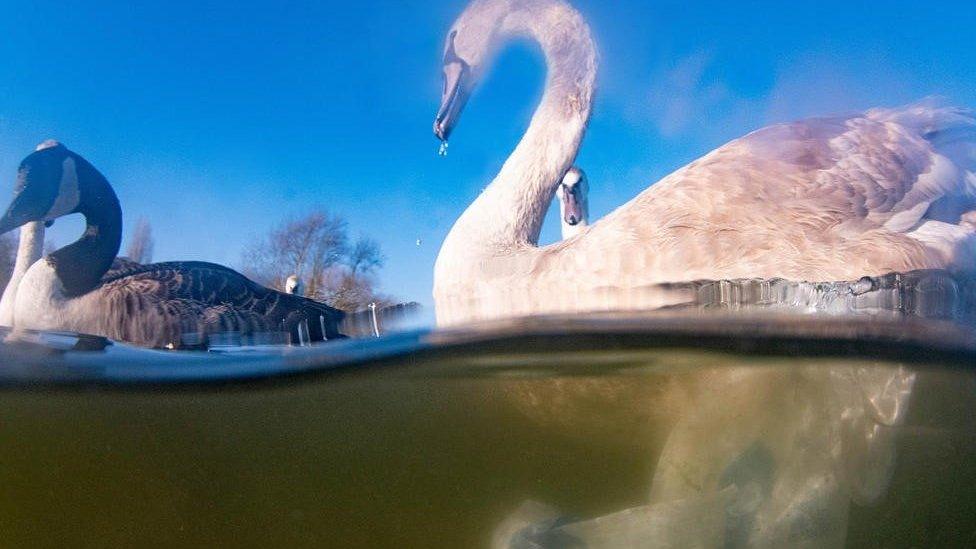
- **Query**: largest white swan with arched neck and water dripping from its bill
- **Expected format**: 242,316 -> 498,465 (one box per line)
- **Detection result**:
434,0 -> 976,324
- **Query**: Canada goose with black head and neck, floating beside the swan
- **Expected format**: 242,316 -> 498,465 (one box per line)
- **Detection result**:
0,143 -> 342,347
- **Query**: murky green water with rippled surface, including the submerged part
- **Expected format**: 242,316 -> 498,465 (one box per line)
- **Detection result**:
0,312 -> 976,547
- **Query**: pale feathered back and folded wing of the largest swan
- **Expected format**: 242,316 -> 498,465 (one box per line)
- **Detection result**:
576,106 -> 976,287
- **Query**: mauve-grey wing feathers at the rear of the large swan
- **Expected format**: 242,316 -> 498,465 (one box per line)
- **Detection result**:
730,104 -> 976,233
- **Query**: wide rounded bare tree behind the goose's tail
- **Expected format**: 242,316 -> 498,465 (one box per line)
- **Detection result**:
242,209 -> 389,311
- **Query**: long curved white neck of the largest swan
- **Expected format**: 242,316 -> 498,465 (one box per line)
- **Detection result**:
435,2 -> 596,268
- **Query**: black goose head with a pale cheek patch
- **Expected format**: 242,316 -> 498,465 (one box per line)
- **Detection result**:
0,140 -> 86,234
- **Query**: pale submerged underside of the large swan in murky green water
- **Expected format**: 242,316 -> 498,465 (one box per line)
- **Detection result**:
494,364 -> 916,547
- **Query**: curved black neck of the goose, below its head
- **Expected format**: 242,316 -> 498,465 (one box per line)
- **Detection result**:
48,156 -> 122,297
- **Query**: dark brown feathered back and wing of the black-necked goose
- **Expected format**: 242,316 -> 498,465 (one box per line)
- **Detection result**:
89,262 -> 343,346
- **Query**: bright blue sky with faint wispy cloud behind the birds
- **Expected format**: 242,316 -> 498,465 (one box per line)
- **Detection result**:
0,0 -> 976,304
